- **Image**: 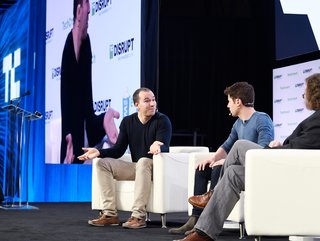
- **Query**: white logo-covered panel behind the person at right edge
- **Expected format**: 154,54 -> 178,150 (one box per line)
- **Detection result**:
273,59 -> 320,142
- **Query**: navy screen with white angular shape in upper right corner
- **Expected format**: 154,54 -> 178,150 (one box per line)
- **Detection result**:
275,0 -> 320,60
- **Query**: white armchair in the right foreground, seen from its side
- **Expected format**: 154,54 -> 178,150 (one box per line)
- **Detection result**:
244,149 -> 320,240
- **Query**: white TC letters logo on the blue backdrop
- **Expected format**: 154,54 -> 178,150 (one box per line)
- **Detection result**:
2,48 -> 21,102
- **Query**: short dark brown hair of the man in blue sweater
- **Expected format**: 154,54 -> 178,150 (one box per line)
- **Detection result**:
224,82 -> 255,107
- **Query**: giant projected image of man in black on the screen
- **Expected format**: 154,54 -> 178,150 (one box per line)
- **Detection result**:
60,0 -> 120,164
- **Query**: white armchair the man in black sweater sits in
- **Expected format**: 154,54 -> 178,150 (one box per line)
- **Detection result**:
92,146 -> 209,227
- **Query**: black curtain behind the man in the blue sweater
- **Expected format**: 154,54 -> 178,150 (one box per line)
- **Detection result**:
158,0 -> 274,150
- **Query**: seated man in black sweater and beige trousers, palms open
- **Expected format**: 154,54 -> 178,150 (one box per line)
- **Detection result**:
78,88 -> 172,228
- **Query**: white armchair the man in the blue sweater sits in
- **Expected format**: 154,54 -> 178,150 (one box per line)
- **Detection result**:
188,152 -> 244,239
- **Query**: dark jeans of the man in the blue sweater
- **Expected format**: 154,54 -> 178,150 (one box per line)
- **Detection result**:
192,165 -> 222,217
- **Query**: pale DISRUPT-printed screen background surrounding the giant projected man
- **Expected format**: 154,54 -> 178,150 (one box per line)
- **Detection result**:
45,0 -> 141,164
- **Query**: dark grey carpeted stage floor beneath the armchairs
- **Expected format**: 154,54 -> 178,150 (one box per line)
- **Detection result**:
0,203 -> 288,241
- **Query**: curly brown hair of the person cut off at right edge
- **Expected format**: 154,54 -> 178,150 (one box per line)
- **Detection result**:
305,73 -> 320,110
